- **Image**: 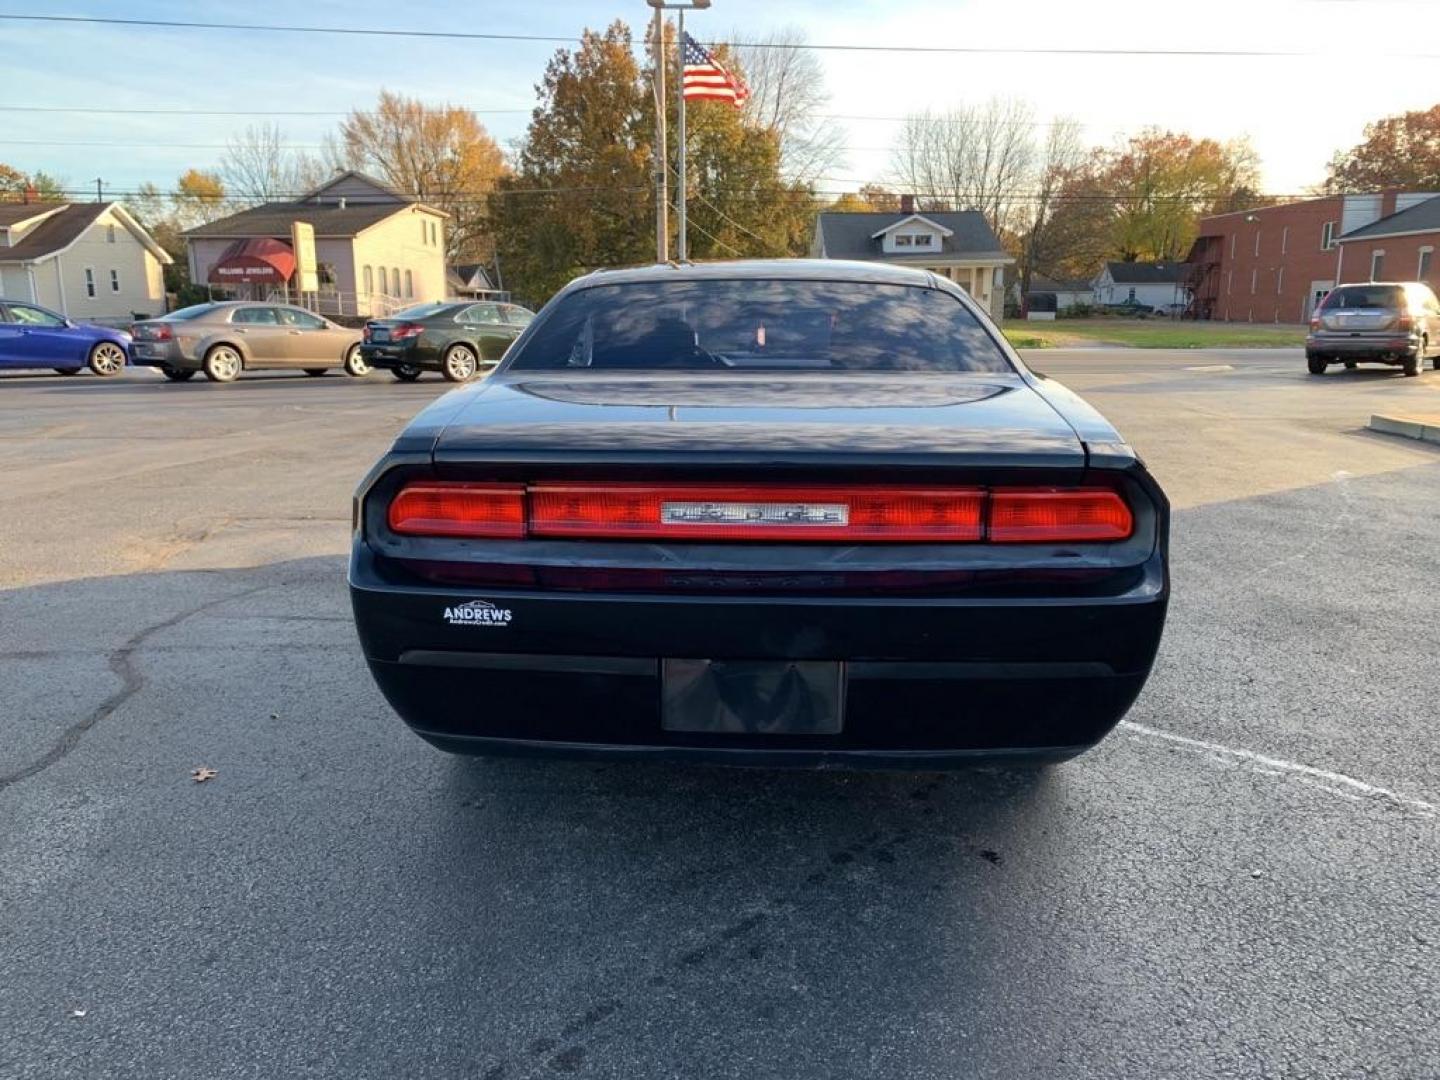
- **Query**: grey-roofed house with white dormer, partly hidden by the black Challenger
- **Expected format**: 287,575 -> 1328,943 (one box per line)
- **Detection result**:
811,196 -> 1015,321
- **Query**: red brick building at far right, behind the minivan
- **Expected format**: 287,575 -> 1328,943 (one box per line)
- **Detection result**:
1187,192 -> 1440,323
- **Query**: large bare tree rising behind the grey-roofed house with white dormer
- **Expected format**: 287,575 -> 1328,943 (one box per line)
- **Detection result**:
891,98 -> 1037,233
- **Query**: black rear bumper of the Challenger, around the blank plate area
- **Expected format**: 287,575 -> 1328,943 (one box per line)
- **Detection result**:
350,541 -> 1166,769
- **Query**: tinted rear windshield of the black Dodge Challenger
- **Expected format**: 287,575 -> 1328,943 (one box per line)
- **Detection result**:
511,281 -> 1011,372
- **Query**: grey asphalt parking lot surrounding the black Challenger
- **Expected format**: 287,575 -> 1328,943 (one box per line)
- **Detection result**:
0,348 -> 1440,1080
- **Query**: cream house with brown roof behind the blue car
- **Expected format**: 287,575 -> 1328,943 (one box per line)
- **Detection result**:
0,203 -> 173,321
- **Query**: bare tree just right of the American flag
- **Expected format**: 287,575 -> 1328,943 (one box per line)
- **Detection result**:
736,26 -> 845,184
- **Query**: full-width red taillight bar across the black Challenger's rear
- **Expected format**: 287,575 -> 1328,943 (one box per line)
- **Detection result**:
389,481 -> 1135,543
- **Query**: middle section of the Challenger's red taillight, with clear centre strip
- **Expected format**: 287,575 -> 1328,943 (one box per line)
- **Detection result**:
530,484 -> 985,543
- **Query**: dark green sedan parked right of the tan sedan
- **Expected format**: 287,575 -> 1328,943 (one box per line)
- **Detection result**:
360,300 -> 534,383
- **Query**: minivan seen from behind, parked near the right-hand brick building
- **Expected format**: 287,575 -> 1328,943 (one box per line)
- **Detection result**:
1305,281 -> 1440,376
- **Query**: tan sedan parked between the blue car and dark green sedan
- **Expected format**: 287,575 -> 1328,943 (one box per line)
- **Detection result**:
134,301 -> 370,383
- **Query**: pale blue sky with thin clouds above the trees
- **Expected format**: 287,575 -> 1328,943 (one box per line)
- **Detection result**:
0,0 -> 1440,201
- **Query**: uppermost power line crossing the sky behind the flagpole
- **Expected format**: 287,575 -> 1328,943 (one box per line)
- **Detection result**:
0,14 -> 1440,60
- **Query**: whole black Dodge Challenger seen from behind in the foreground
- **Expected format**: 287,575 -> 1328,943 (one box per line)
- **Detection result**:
350,261 -> 1169,769
